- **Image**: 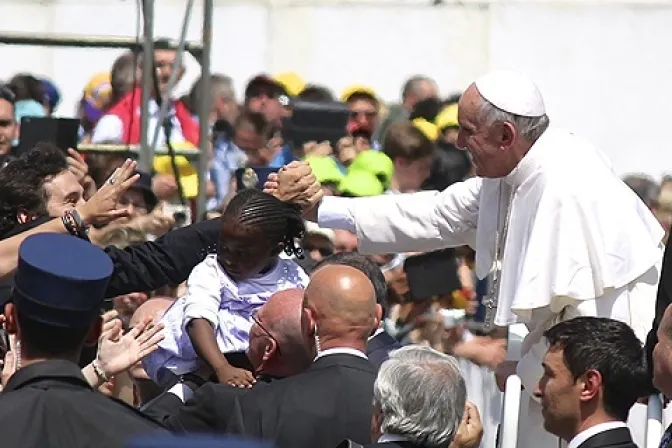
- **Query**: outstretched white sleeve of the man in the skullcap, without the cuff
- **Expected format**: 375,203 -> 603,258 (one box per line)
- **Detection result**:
348,178 -> 482,253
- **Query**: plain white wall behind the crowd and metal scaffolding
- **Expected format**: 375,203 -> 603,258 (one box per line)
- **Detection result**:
0,0 -> 672,176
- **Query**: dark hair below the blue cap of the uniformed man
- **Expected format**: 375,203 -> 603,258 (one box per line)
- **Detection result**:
17,312 -> 89,358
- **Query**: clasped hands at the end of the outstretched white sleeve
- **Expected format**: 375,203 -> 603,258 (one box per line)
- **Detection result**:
264,162 -> 324,211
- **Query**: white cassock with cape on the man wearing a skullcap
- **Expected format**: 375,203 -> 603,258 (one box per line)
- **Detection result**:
318,126 -> 664,448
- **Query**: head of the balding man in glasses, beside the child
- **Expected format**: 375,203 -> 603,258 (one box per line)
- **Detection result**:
248,288 -> 312,377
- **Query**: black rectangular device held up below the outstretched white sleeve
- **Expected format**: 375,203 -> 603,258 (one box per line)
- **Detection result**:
404,249 -> 462,302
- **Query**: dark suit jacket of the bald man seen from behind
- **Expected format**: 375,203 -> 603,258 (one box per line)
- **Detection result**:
167,354 -> 376,448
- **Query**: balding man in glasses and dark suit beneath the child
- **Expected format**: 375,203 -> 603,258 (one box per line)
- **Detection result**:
143,289 -> 313,433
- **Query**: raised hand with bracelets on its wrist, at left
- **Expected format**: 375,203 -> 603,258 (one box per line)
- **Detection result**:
77,159 -> 140,225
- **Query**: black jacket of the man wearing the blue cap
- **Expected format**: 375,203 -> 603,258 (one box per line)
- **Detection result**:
0,360 -> 166,448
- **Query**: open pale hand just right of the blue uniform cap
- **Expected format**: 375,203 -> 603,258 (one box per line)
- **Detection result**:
97,316 -> 163,378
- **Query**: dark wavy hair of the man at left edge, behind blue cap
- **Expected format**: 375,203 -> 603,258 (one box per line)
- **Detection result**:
0,143 -> 68,237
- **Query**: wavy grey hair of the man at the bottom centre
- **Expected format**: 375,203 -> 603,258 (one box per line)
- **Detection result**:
373,345 -> 467,448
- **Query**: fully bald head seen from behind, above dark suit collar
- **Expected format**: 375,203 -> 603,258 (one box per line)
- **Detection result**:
304,265 -> 378,348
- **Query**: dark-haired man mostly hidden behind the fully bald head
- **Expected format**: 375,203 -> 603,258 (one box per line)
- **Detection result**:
313,252 -> 401,369
